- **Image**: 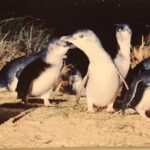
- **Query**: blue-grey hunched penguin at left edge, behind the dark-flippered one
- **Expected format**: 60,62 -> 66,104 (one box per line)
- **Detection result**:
0,49 -> 46,91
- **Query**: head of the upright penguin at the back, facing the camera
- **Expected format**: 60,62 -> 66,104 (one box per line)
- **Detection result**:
116,24 -> 132,42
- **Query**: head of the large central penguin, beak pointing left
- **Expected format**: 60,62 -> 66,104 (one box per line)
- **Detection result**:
61,29 -> 100,52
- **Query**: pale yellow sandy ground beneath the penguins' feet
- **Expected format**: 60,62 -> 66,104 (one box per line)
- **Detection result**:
0,92 -> 150,148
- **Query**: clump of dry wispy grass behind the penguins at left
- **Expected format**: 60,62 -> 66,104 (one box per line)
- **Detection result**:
0,17 -> 54,67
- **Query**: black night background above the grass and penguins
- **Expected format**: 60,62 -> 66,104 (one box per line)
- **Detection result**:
0,0 -> 150,74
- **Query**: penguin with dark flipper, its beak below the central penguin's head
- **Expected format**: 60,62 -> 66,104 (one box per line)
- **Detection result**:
16,39 -> 74,106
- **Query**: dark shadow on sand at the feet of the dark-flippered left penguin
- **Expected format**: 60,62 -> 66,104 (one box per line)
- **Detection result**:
0,99 -> 67,125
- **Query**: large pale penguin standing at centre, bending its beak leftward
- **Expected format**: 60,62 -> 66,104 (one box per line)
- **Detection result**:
61,29 -> 125,113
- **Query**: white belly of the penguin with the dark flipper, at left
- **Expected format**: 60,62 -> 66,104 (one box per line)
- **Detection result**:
31,67 -> 60,95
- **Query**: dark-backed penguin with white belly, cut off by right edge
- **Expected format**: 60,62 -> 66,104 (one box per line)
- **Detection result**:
122,58 -> 150,118
